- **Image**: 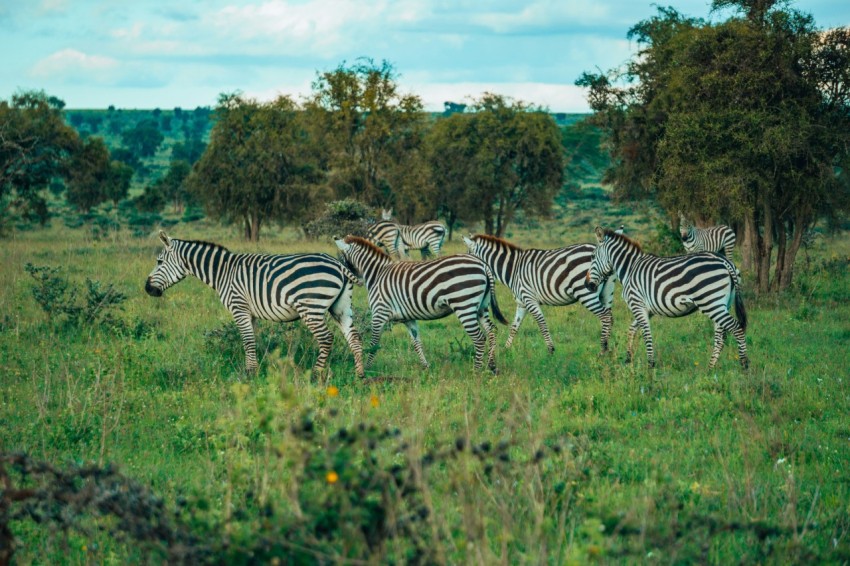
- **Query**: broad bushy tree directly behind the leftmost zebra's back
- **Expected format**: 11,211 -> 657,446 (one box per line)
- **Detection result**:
186,94 -> 319,242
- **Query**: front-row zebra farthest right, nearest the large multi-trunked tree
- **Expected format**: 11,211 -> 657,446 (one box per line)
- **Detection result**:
587,227 -> 749,369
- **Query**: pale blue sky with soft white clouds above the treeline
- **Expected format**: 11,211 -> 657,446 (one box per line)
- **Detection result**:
0,0 -> 850,112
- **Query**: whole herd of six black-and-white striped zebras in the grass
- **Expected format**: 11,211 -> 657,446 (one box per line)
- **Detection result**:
145,211 -> 749,377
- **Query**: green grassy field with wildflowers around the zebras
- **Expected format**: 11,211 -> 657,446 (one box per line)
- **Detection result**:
0,215 -> 850,564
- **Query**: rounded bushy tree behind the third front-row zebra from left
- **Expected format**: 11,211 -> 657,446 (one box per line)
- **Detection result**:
429,93 -> 564,236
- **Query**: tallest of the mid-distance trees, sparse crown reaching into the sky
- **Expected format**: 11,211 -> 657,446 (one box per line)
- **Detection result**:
305,59 -> 433,211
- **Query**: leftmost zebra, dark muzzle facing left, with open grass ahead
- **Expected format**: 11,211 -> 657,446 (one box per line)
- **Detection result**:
145,231 -> 364,377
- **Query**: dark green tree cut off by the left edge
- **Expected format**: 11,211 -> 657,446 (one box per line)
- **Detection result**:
0,91 -> 79,223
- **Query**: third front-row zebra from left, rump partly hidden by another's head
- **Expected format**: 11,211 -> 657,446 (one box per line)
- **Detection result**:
463,234 -> 614,354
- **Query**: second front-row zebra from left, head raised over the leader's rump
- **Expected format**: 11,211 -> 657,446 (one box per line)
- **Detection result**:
335,236 -> 507,373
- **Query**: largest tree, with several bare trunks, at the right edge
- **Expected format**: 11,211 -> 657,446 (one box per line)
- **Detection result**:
577,0 -> 850,292
